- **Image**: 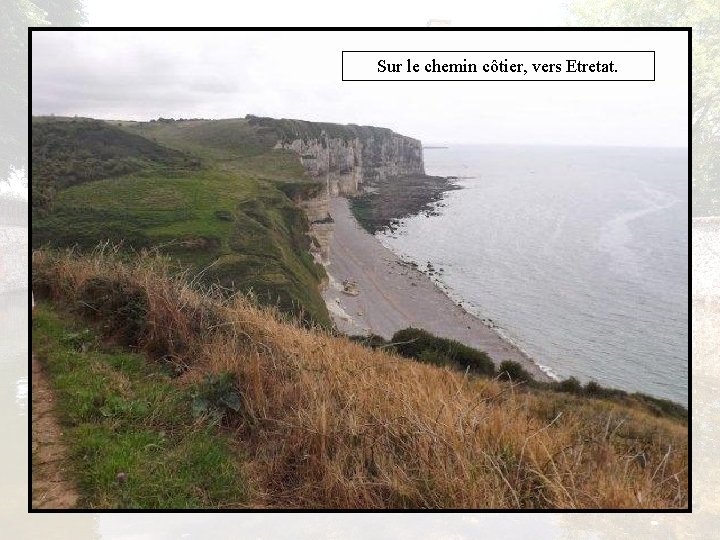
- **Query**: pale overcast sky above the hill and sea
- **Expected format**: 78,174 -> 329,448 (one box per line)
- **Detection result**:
32,30 -> 687,146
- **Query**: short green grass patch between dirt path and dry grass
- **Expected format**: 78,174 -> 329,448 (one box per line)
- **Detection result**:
32,305 -> 248,508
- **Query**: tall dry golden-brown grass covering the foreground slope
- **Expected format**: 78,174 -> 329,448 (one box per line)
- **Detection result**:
33,249 -> 688,508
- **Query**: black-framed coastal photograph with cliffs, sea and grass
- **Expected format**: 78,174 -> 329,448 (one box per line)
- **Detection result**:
29,27 -> 692,510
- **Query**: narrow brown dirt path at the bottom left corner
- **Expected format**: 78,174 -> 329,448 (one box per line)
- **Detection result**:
32,356 -> 78,508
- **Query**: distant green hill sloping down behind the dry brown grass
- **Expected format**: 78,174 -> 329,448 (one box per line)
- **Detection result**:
31,118 -> 329,324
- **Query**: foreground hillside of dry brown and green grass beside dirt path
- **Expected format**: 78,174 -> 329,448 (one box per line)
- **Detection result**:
32,250 -> 689,509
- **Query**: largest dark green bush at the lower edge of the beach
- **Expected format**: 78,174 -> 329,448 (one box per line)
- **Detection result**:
391,328 -> 495,376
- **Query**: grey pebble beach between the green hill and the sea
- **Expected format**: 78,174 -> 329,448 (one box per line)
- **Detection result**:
322,197 -> 554,382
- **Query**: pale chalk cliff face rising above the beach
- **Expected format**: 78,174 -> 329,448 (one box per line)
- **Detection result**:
255,117 -> 425,260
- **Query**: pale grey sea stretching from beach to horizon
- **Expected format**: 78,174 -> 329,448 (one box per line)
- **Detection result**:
378,146 -> 689,404
